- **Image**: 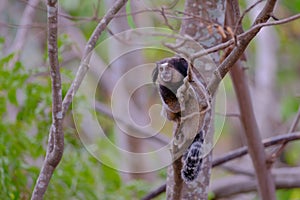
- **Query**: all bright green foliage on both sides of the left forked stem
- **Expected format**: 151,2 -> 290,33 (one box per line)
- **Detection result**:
0,54 -> 156,200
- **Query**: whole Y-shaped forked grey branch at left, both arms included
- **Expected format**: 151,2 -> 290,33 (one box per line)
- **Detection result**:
31,0 -> 127,200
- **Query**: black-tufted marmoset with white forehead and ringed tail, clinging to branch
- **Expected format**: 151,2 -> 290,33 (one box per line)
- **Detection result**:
152,57 -> 204,182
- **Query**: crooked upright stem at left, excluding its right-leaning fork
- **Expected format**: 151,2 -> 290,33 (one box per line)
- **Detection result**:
31,0 -> 64,200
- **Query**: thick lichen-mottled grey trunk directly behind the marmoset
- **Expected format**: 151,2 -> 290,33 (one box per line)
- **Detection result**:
167,0 -> 225,199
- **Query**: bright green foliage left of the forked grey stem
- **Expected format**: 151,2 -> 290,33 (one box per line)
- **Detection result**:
0,54 -> 51,199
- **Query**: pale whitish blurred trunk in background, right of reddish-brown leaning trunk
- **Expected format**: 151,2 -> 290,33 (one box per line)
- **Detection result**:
247,0 -> 280,138
